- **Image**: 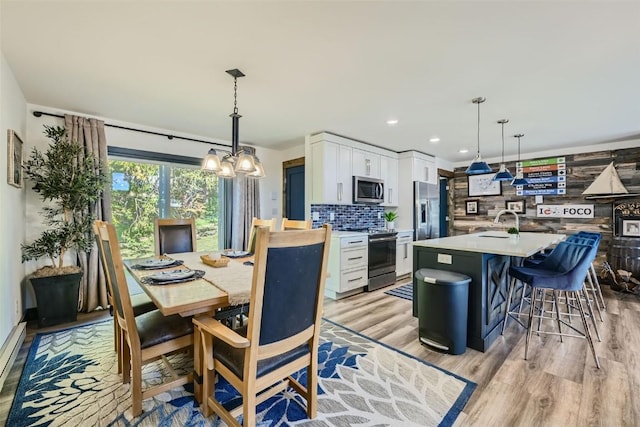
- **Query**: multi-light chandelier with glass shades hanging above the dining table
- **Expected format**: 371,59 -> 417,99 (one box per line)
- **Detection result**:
202,68 -> 265,178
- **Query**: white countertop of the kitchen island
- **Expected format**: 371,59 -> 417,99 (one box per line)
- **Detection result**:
413,231 -> 566,258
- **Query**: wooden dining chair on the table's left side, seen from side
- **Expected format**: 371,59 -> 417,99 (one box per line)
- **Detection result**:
97,223 -> 193,417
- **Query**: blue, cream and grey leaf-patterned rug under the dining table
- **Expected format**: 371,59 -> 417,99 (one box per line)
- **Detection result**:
7,320 -> 476,427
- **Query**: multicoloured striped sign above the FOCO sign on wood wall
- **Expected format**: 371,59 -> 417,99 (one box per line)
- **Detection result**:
516,157 -> 567,196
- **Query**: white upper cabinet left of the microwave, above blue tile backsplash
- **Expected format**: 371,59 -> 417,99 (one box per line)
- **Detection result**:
311,141 -> 353,204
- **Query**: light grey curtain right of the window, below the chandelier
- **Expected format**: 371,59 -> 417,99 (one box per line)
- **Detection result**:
231,147 -> 260,250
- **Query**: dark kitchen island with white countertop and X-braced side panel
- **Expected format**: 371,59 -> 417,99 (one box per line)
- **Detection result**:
413,231 -> 566,352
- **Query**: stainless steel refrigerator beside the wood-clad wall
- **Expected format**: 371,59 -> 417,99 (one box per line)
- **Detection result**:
413,181 -> 440,240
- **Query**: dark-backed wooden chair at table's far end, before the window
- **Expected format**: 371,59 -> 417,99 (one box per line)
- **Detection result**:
154,218 -> 197,255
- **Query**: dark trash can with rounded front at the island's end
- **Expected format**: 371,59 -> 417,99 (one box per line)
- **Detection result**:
414,268 -> 471,354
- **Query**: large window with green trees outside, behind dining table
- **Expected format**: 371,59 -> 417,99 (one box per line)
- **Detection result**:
109,147 -> 219,258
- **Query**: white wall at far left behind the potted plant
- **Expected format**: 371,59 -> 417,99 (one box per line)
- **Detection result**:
0,52 -> 28,346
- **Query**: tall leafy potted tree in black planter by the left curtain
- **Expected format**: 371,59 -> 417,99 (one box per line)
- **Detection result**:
21,125 -> 106,327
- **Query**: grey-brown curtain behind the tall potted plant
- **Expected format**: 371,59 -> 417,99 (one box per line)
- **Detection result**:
64,115 -> 111,312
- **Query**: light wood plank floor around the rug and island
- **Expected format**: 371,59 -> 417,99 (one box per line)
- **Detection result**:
0,279 -> 640,427
